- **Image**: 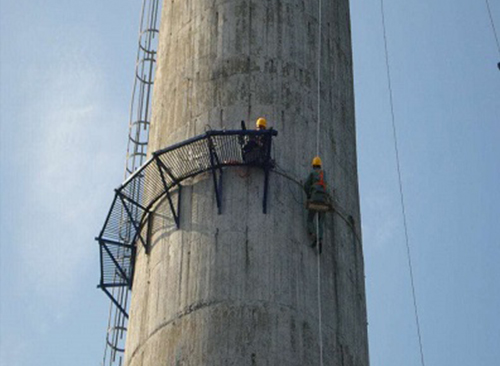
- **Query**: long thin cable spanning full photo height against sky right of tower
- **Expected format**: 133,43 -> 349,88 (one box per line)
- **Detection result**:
380,0 -> 425,366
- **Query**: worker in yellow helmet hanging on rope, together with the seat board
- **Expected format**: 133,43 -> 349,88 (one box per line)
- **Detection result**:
304,156 -> 332,253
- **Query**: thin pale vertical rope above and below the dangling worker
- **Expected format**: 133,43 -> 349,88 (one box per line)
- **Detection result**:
316,0 -> 323,366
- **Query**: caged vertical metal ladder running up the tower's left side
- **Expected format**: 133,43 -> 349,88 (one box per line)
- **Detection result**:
101,0 -> 161,366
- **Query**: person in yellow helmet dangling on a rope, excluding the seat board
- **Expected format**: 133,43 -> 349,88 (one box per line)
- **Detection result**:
304,156 -> 328,248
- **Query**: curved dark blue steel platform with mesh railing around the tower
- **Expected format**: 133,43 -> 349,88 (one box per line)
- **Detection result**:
96,129 -> 278,317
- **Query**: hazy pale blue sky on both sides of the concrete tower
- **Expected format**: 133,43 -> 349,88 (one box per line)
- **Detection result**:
0,0 -> 500,366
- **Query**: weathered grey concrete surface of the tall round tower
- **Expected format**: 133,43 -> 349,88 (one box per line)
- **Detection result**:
126,0 -> 369,366
